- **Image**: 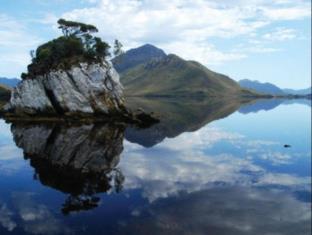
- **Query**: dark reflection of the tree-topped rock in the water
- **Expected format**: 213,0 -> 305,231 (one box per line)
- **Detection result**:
11,123 -> 124,214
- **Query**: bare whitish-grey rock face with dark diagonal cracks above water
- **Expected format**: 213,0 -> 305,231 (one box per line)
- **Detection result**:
4,61 -> 124,115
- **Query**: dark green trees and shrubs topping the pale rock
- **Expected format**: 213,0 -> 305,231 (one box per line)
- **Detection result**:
21,19 -> 110,79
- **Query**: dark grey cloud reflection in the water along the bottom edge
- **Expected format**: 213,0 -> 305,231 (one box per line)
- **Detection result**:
116,186 -> 311,235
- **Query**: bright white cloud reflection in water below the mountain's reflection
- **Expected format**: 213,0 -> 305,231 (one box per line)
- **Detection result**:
120,123 -> 311,202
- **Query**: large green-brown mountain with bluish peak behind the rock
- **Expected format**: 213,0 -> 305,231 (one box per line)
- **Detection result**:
113,45 -> 250,96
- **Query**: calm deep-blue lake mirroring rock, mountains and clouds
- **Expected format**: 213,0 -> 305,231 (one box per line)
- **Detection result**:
0,98 -> 311,235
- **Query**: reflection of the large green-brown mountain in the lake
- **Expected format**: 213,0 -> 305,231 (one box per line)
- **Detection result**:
125,97 -> 242,147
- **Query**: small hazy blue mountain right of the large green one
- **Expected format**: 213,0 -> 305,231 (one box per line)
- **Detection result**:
238,79 -> 285,95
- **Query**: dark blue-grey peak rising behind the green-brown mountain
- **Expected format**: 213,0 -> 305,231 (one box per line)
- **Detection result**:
112,44 -> 166,73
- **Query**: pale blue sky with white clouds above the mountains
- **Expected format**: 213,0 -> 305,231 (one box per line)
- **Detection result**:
0,0 -> 311,88
